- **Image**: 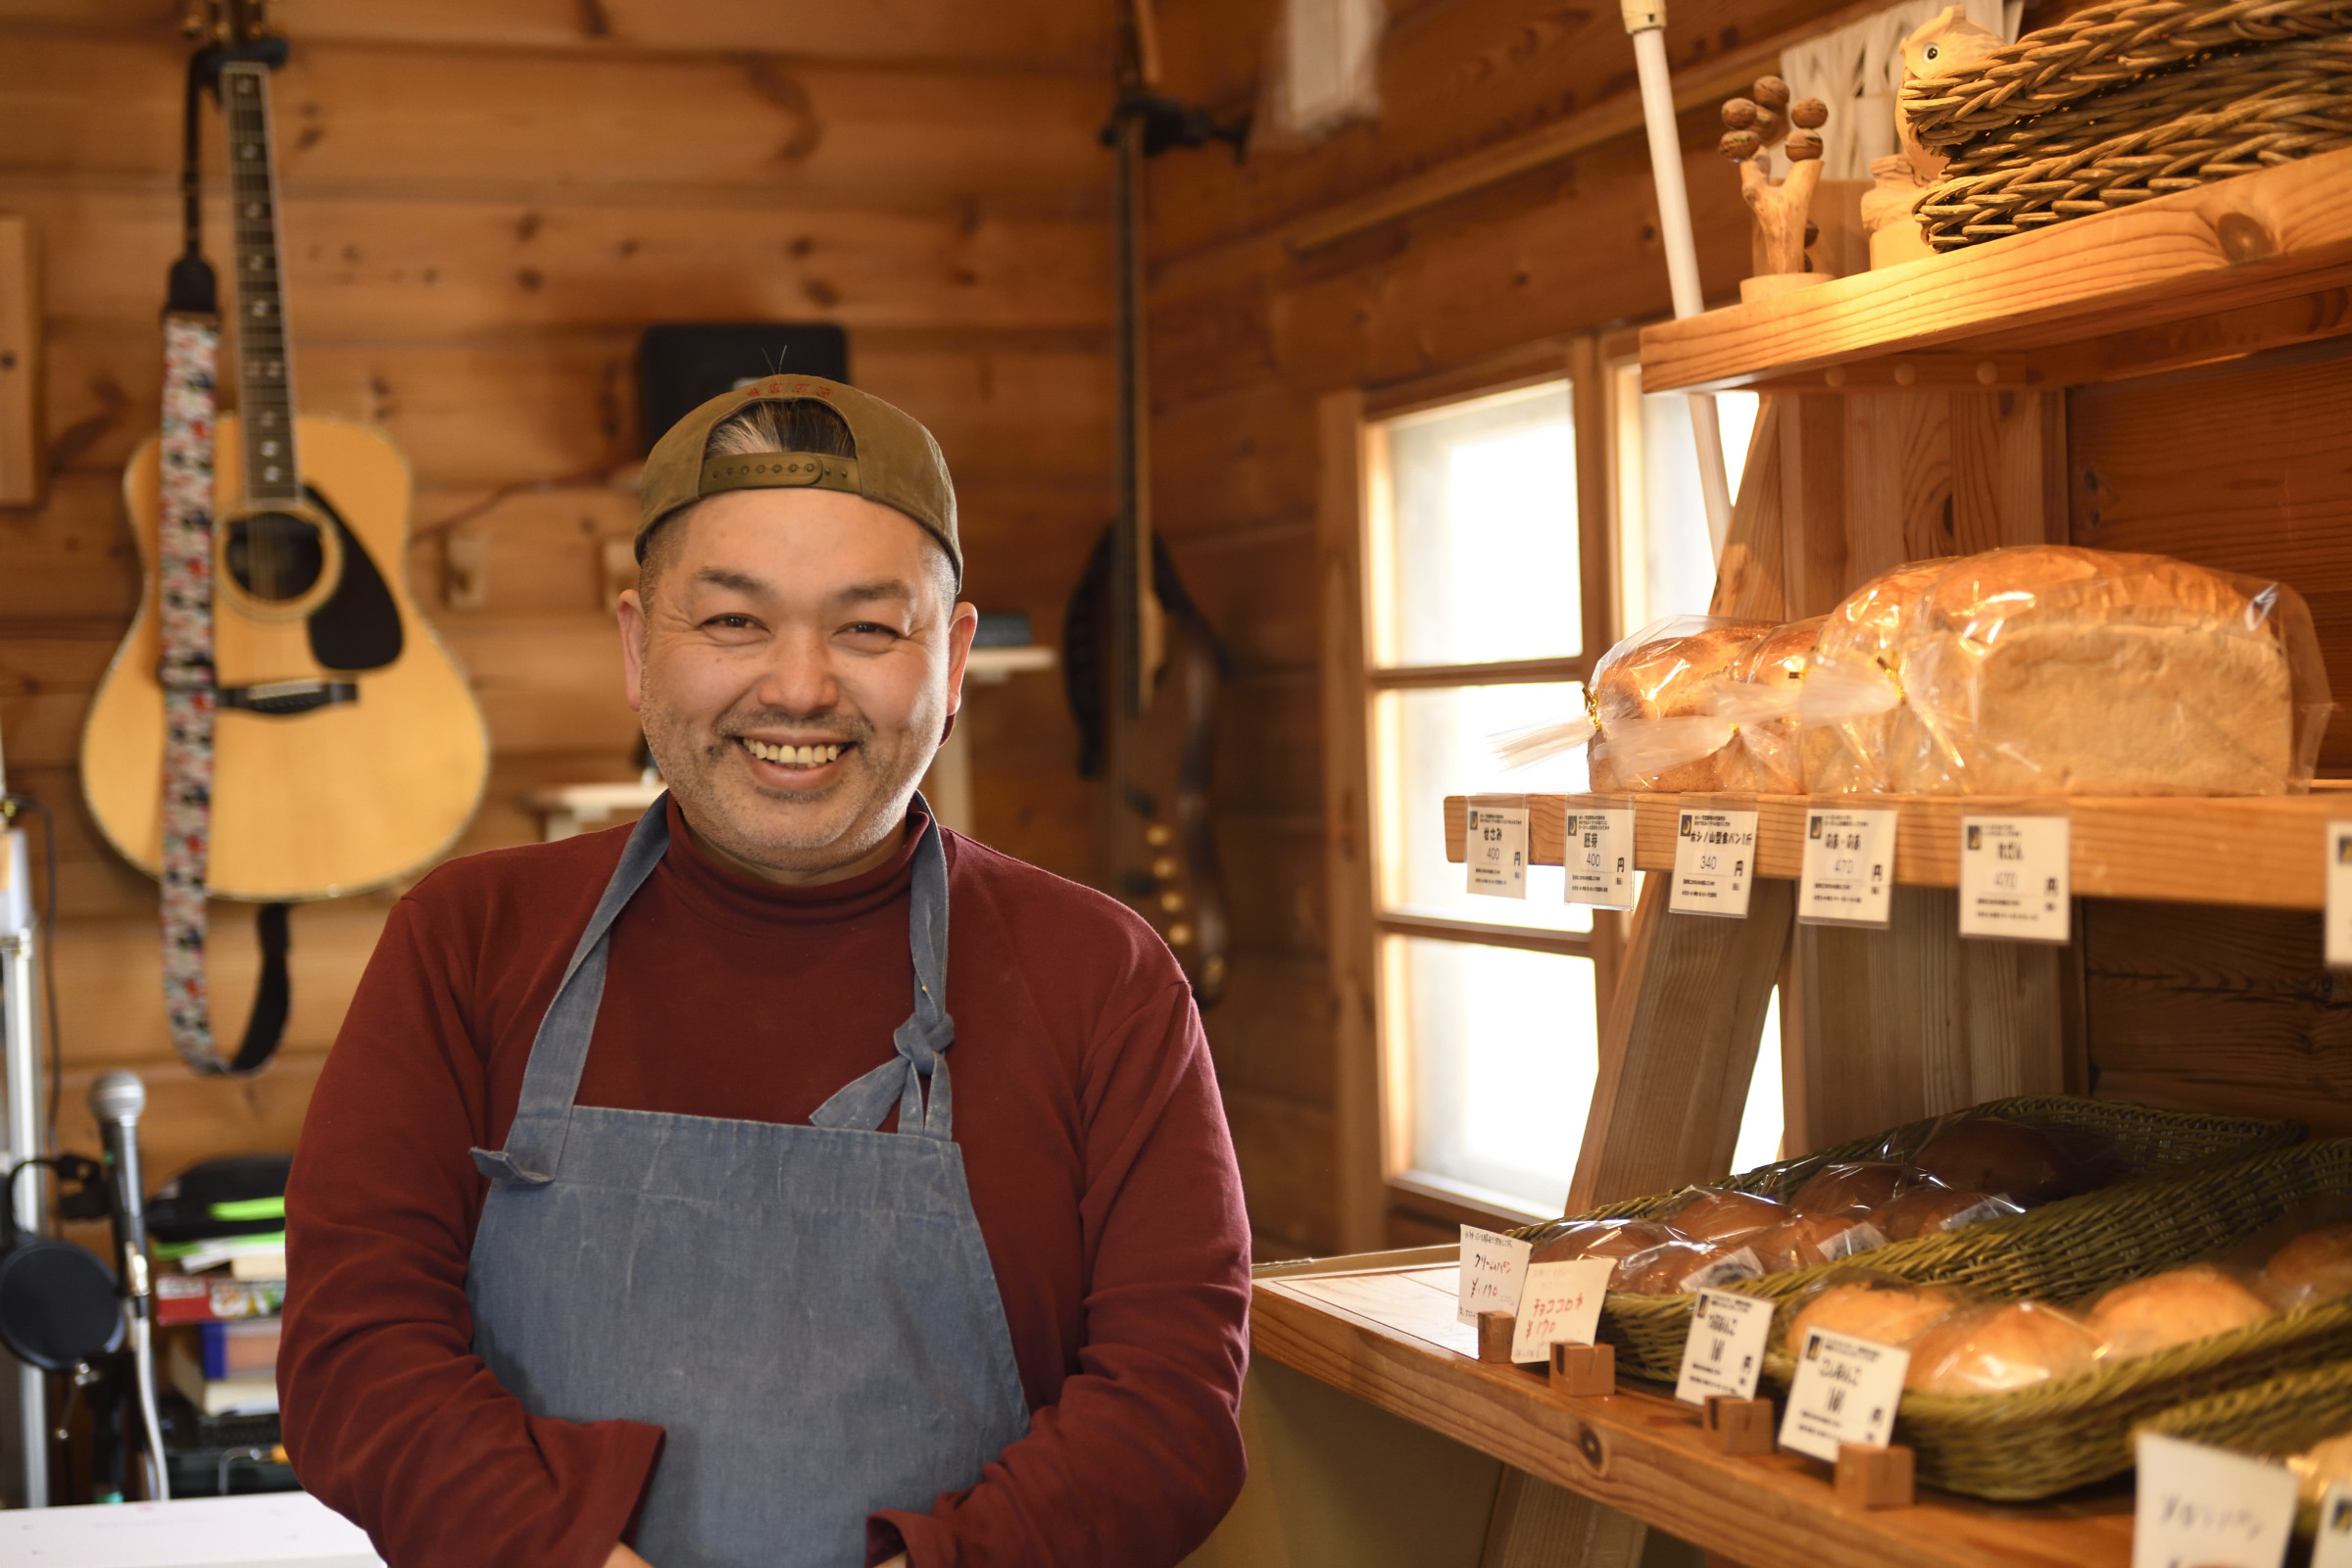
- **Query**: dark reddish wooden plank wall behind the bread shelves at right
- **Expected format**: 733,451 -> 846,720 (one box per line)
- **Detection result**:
2068,338 -> 2352,1136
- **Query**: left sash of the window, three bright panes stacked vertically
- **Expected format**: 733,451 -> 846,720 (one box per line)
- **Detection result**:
1364,376 -> 1611,1215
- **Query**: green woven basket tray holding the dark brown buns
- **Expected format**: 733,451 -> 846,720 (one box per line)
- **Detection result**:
1519,1096 -> 2303,1382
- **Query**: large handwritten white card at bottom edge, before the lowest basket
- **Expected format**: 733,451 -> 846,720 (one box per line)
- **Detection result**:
2131,1432 -> 2295,1568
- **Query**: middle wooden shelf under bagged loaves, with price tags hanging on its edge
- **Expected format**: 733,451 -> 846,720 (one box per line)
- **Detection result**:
1446,788 -> 2352,909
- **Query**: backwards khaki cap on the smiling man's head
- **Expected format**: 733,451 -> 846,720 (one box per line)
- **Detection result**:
637,376 -> 964,588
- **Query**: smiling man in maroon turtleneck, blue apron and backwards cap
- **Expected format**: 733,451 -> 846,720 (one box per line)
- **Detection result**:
277,376 -> 1249,1568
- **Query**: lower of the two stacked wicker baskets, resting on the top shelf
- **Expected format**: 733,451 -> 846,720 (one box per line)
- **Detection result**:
1917,34 -> 2352,252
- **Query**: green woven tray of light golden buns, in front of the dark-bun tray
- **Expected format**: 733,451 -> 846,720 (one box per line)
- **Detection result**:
1757,1138 -> 2352,1502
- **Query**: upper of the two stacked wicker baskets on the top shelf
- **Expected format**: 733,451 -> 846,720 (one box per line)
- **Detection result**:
1903,0 -> 2352,148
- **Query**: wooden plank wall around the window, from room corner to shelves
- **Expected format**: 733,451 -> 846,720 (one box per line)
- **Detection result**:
1151,0 -> 1833,1255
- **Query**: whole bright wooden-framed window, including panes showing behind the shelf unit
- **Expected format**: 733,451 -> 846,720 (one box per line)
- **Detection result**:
1334,338 -> 1781,1218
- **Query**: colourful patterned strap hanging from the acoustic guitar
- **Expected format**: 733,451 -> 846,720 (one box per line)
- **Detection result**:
155,52 -> 287,1074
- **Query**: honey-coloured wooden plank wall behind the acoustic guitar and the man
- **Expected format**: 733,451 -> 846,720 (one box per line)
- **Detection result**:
0,0 -> 1114,1189
